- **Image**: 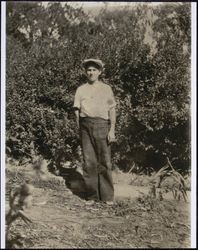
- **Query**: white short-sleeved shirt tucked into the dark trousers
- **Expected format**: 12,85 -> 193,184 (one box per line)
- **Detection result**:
74,82 -> 116,120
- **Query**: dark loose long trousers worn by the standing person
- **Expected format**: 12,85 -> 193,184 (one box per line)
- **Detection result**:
80,117 -> 114,201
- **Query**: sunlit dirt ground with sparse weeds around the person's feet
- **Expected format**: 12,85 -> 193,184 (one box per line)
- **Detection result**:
6,162 -> 190,249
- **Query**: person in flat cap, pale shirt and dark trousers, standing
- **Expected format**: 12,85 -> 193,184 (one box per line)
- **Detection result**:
74,59 -> 116,204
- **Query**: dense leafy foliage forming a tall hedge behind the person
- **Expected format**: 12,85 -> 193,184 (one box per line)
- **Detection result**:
6,2 -> 191,174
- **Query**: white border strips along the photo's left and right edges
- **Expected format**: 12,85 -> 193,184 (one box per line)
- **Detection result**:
0,1 -> 197,249
